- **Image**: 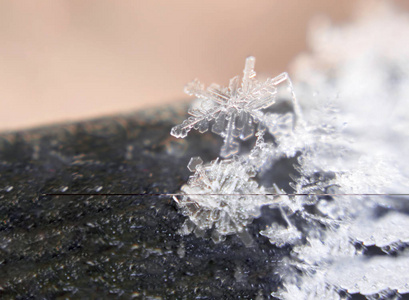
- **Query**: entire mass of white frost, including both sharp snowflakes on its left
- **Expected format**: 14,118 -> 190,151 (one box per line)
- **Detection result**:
172,2 -> 409,299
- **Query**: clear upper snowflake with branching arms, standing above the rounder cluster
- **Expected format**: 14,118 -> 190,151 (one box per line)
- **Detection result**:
171,56 -> 300,158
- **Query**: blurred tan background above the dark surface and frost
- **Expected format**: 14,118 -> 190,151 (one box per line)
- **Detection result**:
0,0 -> 404,130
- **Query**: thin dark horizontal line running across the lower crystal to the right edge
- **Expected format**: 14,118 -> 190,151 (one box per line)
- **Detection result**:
40,193 -> 409,197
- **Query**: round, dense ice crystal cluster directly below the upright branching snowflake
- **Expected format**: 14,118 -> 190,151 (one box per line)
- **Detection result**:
174,157 -> 273,242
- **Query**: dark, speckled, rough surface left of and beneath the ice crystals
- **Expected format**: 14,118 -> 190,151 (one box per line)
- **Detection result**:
0,107 -> 288,299
